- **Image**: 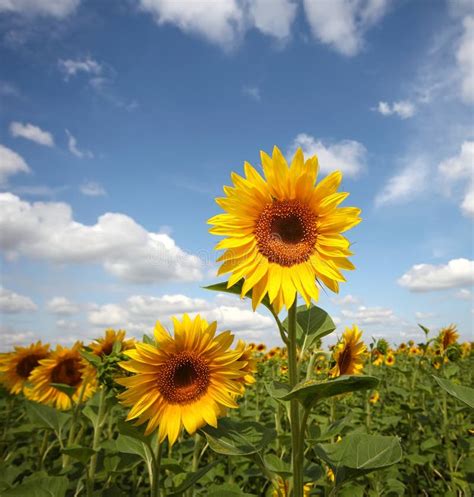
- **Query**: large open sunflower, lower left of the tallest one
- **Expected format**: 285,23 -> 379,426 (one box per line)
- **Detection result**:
117,314 -> 250,445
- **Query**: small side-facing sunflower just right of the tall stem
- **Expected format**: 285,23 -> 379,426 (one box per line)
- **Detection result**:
329,325 -> 367,377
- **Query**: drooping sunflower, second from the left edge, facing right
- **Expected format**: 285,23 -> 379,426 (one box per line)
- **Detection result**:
28,342 -> 96,410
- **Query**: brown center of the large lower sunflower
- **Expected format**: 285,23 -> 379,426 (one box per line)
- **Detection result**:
158,352 -> 211,404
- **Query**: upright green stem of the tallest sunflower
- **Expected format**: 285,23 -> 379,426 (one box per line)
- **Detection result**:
288,298 -> 304,497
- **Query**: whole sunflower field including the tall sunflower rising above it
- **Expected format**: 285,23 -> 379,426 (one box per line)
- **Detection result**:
0,147 -> 474,497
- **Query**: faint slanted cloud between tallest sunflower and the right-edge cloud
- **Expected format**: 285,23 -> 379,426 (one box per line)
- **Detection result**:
375,158 -> 428,206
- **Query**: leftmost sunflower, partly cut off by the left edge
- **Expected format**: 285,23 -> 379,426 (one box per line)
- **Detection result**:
0,341 -> 49,394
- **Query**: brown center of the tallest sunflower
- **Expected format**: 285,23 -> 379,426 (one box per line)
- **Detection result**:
255,199 -> 317,267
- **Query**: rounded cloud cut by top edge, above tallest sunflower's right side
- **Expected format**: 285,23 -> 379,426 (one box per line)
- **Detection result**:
303,0 -> 389,56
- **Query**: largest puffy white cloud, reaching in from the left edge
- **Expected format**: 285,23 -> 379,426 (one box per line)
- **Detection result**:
0,193 -> 202,283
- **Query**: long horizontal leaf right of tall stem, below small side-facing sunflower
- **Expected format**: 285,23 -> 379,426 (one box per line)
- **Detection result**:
281,375 -> 379,409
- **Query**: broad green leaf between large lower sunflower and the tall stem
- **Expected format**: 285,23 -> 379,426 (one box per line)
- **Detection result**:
201,418 -> 276,456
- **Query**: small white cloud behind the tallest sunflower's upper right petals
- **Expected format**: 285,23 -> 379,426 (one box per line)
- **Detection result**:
288,133 -> 367,177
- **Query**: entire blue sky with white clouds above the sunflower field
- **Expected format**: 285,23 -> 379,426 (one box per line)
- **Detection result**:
0,0 -> 474,348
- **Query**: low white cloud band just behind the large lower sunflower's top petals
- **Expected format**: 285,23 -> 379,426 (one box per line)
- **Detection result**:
88,294 -> 277,341
